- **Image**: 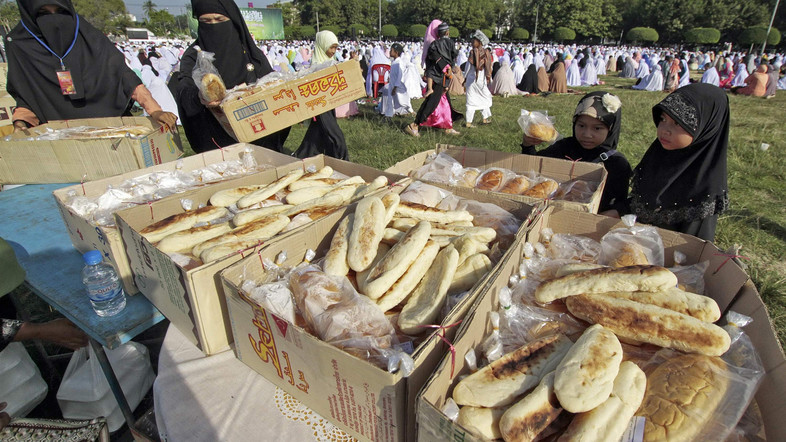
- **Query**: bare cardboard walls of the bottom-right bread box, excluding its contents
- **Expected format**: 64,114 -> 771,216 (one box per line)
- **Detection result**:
418,209 -> 786,441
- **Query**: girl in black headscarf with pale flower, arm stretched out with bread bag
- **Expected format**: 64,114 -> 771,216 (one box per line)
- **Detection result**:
521,91 -> 631,216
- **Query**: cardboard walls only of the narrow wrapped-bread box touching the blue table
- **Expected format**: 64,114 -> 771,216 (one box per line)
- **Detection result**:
53,144 -> 299,295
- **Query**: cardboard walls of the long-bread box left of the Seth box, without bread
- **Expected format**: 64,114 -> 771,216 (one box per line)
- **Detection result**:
115,155 -> 405,355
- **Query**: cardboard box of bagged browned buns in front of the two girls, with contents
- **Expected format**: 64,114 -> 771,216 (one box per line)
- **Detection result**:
387,144 -> 608,213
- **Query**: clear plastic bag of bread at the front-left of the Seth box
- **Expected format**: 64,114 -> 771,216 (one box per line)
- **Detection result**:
289,265 -> 406,370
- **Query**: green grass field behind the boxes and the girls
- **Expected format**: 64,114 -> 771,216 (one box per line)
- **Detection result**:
183,77 -> 786,345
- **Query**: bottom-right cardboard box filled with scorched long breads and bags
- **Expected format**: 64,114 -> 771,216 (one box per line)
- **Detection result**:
418,209 -> 786,441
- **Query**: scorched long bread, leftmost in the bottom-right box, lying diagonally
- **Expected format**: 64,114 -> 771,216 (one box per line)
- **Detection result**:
453,335 -> 573,407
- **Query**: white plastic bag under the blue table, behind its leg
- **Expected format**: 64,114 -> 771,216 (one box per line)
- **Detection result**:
57,342 -> 155,431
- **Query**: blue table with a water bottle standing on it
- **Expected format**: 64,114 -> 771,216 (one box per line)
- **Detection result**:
0,184 -> 164,431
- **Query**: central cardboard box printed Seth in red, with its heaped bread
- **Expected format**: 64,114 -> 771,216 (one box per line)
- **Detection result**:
221,182 -> 531,441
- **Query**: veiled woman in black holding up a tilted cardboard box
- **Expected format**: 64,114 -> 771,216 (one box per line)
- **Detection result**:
169,0 -> 289,152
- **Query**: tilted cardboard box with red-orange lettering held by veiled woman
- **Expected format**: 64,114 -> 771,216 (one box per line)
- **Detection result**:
213,60 -> 366,142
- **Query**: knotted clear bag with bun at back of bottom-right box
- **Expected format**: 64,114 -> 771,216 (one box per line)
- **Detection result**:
599,215 -> 664,267
